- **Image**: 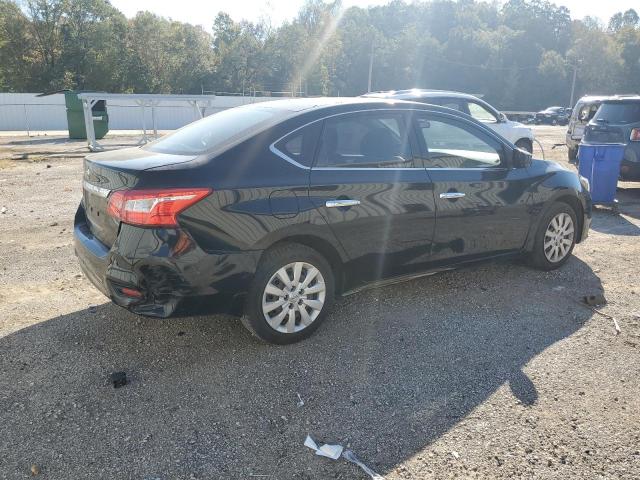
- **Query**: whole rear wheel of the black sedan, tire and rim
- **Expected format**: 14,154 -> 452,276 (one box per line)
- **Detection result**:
242,244 -> 334,345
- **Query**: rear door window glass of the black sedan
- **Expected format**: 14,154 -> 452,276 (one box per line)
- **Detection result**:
316,112 -> 413,168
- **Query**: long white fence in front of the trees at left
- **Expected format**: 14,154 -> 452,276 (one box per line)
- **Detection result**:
0,93 -> 290,132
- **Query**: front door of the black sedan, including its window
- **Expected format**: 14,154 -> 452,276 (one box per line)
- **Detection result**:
415,113 -> 530,263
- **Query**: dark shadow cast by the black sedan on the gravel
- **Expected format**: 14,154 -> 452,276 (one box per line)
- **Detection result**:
0,257 -> 602,479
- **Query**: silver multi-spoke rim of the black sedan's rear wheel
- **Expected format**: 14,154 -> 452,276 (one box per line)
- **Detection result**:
262,262 -> 326,333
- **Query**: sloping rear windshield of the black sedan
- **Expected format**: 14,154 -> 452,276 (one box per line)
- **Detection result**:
144,105 -> 282,155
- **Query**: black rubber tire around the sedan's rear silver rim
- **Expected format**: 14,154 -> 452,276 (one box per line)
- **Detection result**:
242,243 -> 335,345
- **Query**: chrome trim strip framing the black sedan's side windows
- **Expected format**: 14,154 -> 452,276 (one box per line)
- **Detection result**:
269,108 -> 508,171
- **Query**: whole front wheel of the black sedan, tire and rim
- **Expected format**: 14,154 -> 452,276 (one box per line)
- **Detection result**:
529,202 -> 578,270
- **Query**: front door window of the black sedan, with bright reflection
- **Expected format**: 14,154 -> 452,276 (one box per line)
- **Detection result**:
418,118 -> 501,168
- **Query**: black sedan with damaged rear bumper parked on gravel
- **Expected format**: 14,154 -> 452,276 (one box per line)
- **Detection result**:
75,99 -> 591,344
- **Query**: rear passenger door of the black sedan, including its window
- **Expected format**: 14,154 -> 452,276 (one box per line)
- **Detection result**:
309,110 -> 435,283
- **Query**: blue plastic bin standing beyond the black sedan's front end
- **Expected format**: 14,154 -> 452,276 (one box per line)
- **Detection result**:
578,143 -> 626,204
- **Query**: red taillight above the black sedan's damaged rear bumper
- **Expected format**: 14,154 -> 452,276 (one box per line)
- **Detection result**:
107,188 -> 211,227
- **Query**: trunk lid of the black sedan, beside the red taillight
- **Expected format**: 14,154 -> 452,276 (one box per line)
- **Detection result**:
82,148 -> 196,247
